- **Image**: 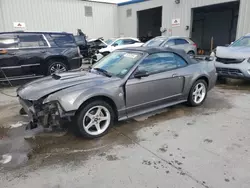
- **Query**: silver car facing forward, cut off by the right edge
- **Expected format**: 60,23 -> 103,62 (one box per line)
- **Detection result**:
213,35 -> 250,79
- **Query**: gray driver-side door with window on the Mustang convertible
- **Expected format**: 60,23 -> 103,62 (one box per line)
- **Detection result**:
126,52 -> 187,116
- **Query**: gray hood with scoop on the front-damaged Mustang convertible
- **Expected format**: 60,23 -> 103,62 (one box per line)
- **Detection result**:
17,71 -> 119,101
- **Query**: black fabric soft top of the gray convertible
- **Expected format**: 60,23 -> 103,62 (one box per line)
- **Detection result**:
119,47 -> 198,64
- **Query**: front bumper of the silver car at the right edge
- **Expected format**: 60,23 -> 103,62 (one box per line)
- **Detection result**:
215,60 -> 250,79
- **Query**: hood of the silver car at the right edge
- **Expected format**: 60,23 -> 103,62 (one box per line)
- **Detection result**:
216,46 -> 250,59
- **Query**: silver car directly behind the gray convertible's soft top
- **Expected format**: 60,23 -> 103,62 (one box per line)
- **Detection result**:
143,36 -> 197,56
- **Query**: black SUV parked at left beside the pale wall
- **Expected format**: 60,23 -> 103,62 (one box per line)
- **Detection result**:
0,32 -> 82,81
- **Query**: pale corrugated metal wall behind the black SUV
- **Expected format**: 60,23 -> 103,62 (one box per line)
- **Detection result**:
0,0 -> 118,38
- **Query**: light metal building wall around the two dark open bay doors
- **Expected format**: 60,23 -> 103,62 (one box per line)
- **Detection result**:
118,0 -> 247,38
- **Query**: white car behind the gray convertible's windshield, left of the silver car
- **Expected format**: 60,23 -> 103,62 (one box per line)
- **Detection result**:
99,37 -> 143,56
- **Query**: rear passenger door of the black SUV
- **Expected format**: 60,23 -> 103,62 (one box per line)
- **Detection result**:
18,34 -> 49,76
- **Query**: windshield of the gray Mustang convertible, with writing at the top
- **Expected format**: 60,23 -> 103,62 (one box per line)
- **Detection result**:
93,51 -> 143,78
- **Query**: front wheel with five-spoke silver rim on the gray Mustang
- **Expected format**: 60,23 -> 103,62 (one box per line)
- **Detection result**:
74,100 -> 115,139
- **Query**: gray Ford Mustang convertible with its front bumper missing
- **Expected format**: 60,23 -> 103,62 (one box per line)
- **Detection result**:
17,47 -> 217,138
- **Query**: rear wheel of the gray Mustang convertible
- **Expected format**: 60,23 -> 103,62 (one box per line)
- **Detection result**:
188,79 -> 207,106
